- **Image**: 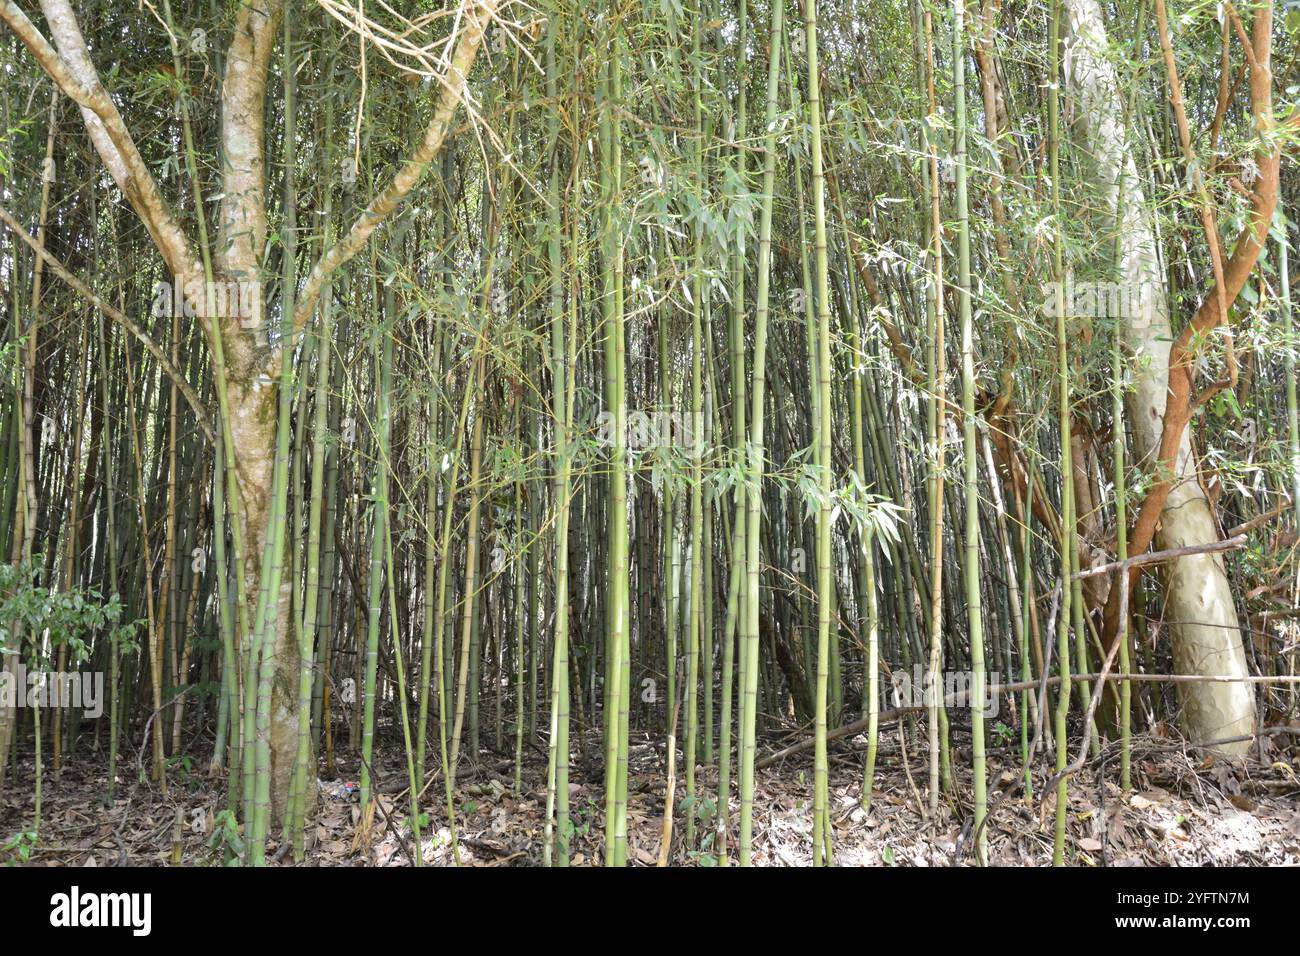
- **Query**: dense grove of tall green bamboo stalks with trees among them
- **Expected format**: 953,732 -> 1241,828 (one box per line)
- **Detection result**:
0,0 -> 1300,866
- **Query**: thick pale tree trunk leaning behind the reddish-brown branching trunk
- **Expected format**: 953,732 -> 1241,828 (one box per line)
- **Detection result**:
1065,0 -> 1255,752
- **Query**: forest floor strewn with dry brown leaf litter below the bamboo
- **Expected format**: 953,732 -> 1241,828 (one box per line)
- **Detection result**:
0,727 -> 1300,866
